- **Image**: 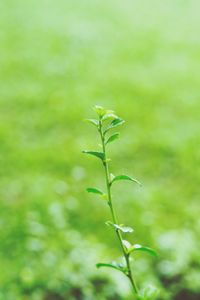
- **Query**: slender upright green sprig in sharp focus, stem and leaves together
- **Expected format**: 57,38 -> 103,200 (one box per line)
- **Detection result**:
83,106 -> 157,299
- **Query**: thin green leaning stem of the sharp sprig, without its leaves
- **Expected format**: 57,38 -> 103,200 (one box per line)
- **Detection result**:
99,119 -> 138,294
